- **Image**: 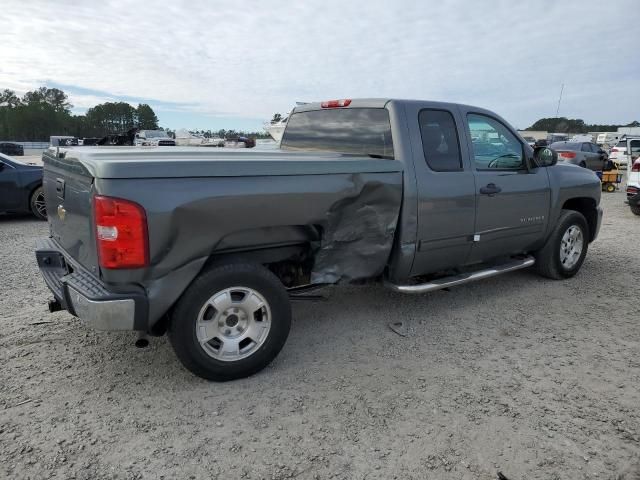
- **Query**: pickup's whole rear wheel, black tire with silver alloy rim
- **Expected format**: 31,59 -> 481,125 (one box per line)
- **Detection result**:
168,263 -> 291,381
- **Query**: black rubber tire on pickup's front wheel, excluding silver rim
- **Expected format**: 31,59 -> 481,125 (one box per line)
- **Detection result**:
535,210 -> 589,280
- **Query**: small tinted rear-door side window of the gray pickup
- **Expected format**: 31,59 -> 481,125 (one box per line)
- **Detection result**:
418,110 -> 462,172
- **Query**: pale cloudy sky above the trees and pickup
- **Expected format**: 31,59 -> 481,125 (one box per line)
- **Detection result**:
0,0 -> 640,130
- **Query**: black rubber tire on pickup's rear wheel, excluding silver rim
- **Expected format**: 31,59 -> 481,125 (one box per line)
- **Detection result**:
168,263 -> 291,382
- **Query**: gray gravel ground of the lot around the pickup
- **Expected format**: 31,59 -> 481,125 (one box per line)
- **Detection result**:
0,189 -> 640,480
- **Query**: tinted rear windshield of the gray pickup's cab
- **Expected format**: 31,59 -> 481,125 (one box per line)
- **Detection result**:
280,108 -> 393,158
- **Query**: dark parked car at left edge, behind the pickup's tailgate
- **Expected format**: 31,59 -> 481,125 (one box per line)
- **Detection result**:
0,154 -> 47,220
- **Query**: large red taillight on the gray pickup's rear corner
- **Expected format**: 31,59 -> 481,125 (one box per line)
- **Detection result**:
93,195 -> 149,268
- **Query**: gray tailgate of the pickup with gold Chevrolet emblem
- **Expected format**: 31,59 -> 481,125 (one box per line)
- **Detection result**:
42,151 -> 98,274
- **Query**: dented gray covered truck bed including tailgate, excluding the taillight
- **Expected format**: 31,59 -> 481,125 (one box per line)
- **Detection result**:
43,147 -> 403,325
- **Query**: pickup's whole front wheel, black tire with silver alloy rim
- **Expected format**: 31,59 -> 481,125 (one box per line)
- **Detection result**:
535,210 -> 589,280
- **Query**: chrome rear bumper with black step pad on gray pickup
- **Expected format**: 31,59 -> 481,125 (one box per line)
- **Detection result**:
36,238 -> 148,331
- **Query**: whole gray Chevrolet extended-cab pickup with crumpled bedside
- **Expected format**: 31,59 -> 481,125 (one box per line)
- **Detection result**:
36,99 -> 602,381
